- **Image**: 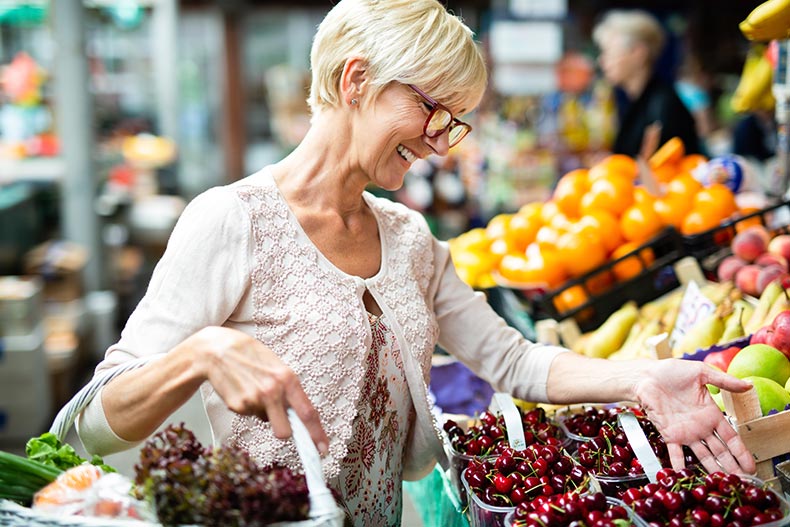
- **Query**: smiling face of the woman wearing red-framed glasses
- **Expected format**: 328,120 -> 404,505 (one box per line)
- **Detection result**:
357,82 -> 464,190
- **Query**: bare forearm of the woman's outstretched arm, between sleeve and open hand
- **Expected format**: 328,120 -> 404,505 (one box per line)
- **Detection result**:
546,353 -> 655,404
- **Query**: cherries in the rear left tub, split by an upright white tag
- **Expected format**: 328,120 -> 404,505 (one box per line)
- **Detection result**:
444,408 -> 563,456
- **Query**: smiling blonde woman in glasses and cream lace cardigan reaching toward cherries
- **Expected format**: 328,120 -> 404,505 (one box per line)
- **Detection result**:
78,0 -> 754,525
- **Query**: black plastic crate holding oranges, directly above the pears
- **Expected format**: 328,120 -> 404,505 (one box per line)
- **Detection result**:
498,227 -> 686,332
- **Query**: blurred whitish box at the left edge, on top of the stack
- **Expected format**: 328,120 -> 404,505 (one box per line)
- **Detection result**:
0,276 -> 43,337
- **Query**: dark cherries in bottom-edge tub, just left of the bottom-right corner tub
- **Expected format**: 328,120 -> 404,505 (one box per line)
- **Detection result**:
510,492 -> 631,527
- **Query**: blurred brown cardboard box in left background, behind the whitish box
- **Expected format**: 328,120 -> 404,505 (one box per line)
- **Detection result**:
24,240 -> 88,302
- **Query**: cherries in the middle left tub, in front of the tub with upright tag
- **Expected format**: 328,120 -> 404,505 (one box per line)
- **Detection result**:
463,443 -> 589,507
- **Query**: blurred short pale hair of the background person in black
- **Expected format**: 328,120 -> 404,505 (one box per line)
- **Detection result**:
592,9 -> 666,62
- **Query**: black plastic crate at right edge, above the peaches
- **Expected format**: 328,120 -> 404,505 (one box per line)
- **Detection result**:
683,201 -> 790,270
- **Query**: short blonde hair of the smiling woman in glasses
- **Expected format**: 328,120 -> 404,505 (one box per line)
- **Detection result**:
307,0 -> 487,114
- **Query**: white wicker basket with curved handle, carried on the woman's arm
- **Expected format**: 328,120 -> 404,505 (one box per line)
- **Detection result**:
0,355 -> 344,527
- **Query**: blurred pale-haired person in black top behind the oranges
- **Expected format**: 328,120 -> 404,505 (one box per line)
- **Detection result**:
593,10 -> 701,157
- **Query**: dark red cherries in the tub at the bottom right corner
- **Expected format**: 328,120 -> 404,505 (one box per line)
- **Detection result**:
622,466 -> 784,527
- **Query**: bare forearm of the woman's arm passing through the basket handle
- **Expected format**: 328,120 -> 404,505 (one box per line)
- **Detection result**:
101,344 -> 205,442
